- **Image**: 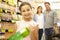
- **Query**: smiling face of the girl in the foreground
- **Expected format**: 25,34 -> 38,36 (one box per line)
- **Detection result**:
21,5 -> 32,19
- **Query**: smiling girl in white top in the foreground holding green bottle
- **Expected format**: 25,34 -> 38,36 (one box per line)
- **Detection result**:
17,2 -> 38,40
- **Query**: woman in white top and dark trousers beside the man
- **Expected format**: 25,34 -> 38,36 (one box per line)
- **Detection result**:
34,6 -> 44,40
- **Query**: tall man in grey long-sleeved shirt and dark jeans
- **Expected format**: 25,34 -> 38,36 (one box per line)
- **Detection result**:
44,2 -> 57,40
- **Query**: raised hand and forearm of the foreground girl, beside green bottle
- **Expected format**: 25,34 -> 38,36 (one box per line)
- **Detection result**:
29,25 -> 38,40
